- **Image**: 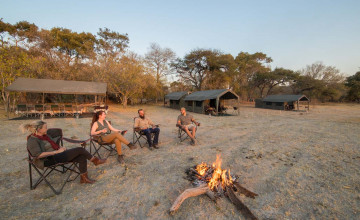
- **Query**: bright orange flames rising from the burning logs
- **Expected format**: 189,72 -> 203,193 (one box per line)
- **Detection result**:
196,154 -> 233,190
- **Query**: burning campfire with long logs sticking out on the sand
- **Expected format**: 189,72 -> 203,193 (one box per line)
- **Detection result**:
170,155 -> 257,219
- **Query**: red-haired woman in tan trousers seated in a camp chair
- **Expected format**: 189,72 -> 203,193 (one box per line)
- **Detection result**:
91,111 -> 136,165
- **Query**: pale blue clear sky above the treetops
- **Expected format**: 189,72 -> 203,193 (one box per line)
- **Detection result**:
0,0 -> 360,76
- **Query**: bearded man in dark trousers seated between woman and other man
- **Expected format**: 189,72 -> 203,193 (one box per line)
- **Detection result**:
134,109 -> 160,150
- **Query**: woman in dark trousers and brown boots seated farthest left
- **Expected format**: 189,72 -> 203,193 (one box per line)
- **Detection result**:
23,121 -> 106,183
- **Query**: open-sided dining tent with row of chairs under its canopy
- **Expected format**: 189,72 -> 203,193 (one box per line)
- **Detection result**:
6,78 -> 107,117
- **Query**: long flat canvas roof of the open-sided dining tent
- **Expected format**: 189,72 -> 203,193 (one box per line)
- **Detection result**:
6,78 -> 107,95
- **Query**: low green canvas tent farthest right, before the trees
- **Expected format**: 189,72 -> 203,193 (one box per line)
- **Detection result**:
255,95 -> 310,110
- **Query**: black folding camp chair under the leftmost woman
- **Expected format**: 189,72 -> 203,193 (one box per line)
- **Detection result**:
27,128 -> 89,195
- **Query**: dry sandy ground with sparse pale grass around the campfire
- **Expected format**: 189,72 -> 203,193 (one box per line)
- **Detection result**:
0,104 -> 360,219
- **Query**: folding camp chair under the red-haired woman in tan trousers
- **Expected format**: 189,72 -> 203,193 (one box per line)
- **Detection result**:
90,121 -> 116,159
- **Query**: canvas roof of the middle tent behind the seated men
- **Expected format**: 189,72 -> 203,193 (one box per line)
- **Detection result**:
184,89 -> 239,101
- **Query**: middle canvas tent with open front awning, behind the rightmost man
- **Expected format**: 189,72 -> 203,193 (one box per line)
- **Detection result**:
184,89 -> 239,114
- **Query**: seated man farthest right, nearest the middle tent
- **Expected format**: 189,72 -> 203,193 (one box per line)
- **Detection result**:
176,107 -> 200,145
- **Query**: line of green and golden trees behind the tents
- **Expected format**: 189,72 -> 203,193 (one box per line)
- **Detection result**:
0,19 -> 360,111
